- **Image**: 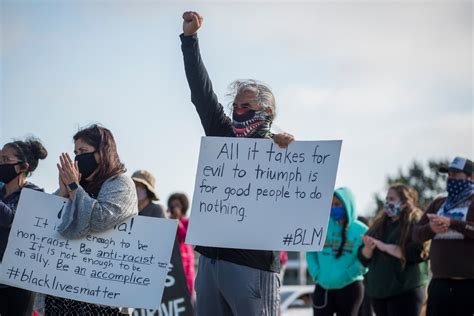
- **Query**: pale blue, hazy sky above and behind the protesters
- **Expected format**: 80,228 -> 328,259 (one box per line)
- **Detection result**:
0,0 -> 474,214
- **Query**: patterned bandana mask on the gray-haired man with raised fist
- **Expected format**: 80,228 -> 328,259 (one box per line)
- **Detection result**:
232,109 -> 273,137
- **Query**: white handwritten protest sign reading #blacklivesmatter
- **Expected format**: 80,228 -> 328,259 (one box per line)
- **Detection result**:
0,189 -> 177,308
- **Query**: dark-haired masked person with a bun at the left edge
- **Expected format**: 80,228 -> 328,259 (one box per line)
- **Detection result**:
0,138 -> 48,315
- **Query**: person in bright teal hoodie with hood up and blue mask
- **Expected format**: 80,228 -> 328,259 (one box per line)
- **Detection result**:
306,188 -> 367,316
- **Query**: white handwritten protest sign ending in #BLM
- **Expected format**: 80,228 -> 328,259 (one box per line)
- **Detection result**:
186,137 -> 342,251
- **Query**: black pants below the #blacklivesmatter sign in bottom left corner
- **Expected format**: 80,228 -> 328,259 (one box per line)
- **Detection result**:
0,286 -> 35,316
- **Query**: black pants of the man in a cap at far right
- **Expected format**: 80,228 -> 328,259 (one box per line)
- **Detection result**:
426,279 -> 474,316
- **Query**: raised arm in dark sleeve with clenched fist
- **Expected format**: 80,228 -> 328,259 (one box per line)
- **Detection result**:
180,12 -> 234,136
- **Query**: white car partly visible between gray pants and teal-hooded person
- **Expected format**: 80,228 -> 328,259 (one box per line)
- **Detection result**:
280,285 -> 314,316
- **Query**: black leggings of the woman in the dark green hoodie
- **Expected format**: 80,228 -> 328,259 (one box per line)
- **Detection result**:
372,287 -> 426,316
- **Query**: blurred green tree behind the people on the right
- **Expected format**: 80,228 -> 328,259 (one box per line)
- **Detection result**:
374,160 -> 449,212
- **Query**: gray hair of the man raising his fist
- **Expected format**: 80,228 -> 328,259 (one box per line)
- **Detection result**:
226,79 -> 276,118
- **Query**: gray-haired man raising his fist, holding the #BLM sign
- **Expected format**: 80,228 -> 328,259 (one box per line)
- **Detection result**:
180,12 -> 293,316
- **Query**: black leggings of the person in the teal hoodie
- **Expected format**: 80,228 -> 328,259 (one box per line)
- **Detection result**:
312,281 -> 364,316
